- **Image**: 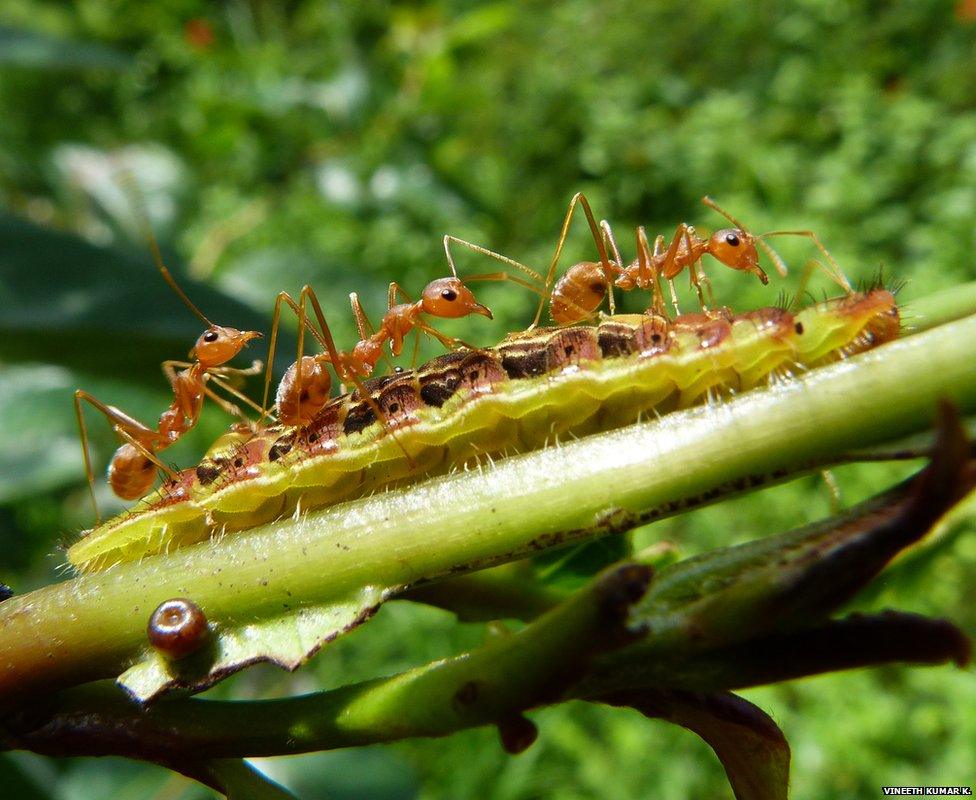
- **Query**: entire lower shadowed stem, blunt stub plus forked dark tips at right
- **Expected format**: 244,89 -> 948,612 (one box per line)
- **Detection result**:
0,428 -> 976,764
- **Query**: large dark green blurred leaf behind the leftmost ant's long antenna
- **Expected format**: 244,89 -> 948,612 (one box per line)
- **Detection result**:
0,215 -> 280,380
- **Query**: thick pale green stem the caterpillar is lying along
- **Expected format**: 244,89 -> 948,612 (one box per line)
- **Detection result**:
0,317 -> 976,705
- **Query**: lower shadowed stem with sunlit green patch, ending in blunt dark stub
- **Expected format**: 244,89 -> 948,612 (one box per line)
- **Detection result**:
7,564 -> 651,761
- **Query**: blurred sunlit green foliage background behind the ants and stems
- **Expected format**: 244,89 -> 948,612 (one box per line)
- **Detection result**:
0,0 -> 976,798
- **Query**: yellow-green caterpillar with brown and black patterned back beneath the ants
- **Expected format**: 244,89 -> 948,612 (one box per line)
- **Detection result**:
67,289 -> 900,571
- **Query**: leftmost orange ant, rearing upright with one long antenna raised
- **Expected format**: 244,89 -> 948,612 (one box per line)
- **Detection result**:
74,234 -> 261,520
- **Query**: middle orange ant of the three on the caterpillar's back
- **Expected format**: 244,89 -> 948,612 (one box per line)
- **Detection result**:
262,269 -> 492,426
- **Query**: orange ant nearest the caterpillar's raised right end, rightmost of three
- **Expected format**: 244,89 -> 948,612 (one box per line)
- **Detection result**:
444,193 -> 853,328
